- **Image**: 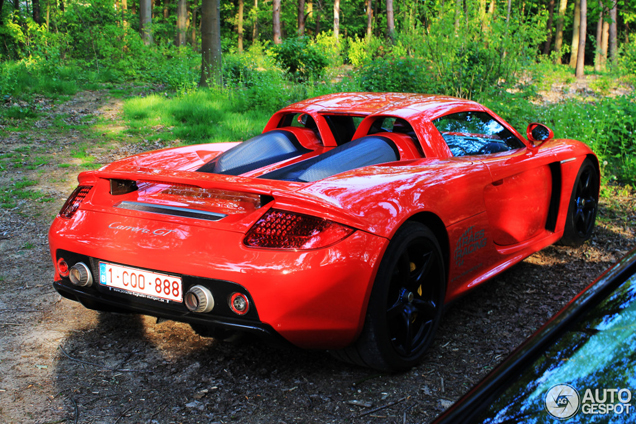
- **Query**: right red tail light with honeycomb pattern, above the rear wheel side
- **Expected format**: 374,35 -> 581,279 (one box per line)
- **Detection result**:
243,209 -> 355,250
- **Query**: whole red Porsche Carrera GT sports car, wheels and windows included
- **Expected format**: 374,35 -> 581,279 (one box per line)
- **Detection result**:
49,93 -> 599,370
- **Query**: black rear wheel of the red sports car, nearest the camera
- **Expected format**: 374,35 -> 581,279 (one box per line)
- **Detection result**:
332,222 -> 446,371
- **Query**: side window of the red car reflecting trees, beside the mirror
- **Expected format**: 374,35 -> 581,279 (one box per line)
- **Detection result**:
433,112 -> 524,156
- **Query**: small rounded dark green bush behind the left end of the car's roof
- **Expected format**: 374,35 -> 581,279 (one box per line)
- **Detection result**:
272,37 -> 329,81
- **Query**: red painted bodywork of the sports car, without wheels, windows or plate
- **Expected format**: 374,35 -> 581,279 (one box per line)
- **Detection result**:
49,93 -> 598,368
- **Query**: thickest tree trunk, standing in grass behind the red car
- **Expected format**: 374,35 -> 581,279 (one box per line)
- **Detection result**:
199,0 -> 221,87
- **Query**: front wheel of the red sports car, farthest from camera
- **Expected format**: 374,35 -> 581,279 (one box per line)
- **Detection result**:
559,159 -> 599,247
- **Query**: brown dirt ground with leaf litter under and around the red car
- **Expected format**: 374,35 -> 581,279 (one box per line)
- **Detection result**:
0,87 -> 636,423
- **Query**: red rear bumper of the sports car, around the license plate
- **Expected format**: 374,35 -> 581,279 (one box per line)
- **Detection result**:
49,211 -> 388,349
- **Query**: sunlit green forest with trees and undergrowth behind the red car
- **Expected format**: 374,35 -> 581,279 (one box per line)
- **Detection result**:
0,0 -> 636,184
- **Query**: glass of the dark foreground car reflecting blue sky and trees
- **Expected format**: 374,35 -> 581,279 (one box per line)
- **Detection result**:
478,275 -> 636,424
